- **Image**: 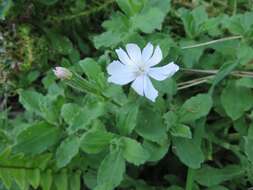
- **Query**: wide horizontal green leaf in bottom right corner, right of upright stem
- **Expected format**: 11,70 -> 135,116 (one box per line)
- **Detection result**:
195,165 -> 245,187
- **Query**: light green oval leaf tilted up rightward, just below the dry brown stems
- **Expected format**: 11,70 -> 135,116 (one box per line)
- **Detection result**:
179,94 -> 213,123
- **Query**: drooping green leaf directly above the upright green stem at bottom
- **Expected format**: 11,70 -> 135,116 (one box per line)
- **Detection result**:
173,137 -> 205,169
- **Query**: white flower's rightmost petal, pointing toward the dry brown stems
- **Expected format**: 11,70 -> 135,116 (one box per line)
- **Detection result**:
148,62 -> 179,81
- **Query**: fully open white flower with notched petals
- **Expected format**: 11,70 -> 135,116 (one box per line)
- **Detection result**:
107,43 -> 179,102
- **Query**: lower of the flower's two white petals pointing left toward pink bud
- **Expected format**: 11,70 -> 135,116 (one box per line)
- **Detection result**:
108,72 -> 136,85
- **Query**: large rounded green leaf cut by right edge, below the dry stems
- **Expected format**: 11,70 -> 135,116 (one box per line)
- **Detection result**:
221,82 -> 253,120
